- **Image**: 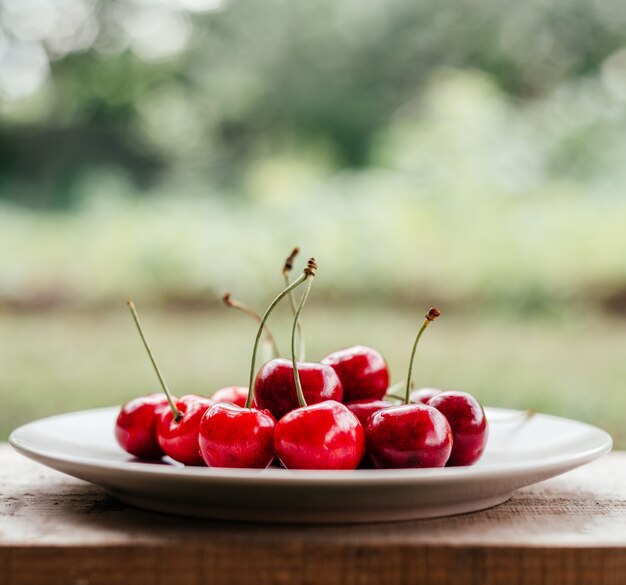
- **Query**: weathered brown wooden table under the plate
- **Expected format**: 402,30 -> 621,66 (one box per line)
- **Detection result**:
0,444 -> 626,585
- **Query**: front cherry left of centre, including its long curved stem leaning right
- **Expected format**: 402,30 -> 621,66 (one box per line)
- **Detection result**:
199,258 -> 316,469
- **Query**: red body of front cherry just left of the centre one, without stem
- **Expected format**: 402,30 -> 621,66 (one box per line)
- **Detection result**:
200,402 -> 276,469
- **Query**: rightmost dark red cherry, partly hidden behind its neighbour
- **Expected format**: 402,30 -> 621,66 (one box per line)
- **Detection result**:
428,392 -> 489,466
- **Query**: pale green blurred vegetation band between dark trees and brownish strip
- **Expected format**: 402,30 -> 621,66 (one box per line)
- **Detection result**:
0,70 -> 626,311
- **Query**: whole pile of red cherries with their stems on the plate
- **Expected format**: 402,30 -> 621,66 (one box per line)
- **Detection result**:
115,248 -> 488,469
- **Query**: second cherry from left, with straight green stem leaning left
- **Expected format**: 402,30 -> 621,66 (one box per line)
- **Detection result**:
127,301 -> 214,465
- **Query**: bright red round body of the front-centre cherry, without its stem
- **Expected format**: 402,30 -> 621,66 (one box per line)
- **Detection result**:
274,400 -> 365,469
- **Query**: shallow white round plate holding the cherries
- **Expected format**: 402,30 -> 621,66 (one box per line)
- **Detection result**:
9,407 -> 612,522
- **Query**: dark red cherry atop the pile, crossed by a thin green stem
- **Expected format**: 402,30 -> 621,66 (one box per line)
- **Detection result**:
254,358 -> 343,420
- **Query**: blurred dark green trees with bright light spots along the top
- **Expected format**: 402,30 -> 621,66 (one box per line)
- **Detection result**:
0,0 -> 626,207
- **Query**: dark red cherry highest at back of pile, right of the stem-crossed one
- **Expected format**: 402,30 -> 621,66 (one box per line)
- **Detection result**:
322,345 -> 389,403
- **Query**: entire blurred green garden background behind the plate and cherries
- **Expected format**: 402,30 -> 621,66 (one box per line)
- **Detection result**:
0,0 -> 626,447
